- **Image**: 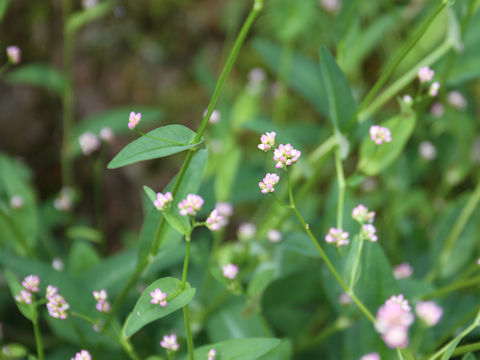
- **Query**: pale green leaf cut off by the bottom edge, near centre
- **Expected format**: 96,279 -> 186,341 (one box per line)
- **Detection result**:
188,338 -> 280,360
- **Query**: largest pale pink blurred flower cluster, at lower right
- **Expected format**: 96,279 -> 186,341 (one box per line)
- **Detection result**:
375,294 -> 413,348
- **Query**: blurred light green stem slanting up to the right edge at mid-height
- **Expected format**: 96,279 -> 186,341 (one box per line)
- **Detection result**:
426,181 -> 480,282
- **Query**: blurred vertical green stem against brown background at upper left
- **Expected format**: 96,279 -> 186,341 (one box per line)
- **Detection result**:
61,0 -> 74,188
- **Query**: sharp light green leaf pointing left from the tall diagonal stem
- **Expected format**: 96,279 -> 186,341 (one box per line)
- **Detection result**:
108,125 -> 199,169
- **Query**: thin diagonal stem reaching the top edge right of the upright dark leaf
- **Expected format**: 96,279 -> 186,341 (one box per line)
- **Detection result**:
349,0 -> 447,126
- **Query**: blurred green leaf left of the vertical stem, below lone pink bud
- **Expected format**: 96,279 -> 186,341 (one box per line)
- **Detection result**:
5,63 -> 65,96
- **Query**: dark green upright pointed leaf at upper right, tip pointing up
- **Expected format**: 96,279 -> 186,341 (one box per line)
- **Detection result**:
320,46 -> 357,131
